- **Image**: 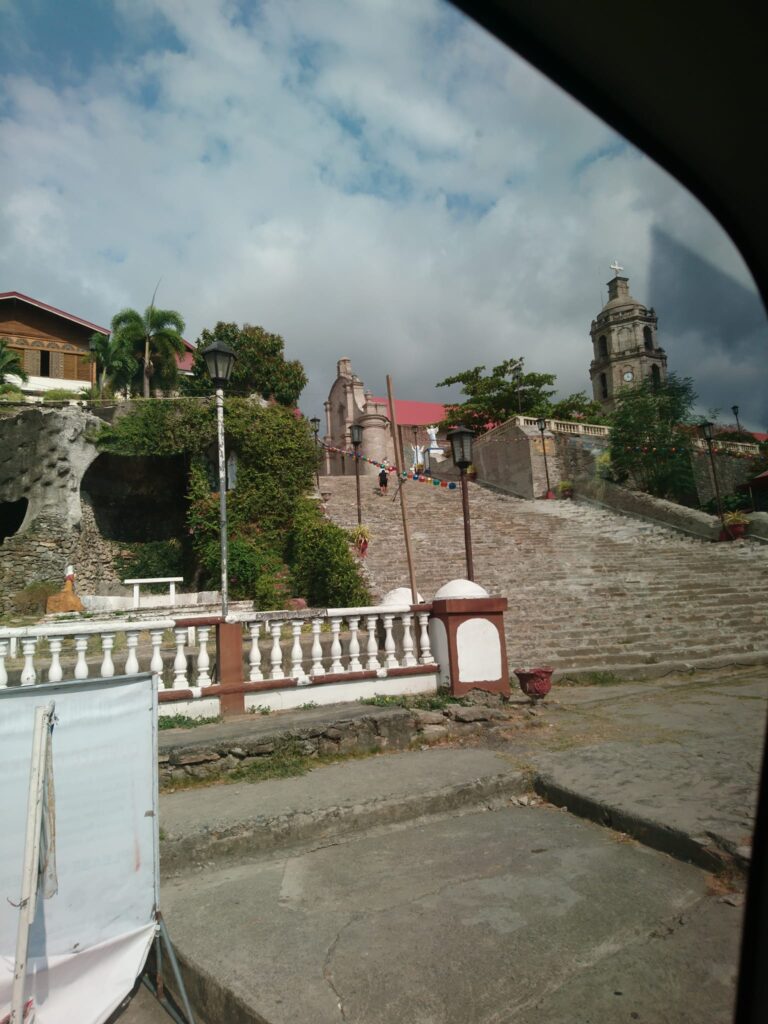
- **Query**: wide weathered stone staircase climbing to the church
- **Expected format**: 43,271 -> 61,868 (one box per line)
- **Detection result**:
321,476 -> 768,670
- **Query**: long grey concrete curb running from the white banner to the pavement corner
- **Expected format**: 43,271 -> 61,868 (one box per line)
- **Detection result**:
160,771 -> 530,878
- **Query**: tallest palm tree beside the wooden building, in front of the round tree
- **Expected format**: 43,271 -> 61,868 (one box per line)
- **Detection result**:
112,303 -> 184,398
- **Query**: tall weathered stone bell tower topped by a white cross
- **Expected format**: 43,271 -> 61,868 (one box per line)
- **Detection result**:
590,260 -> 667,410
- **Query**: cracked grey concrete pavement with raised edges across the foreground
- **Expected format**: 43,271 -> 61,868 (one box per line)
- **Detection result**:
126,669 -> 766,1024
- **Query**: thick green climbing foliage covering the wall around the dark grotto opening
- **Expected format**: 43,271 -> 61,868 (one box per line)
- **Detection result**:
99,398 -> 368,610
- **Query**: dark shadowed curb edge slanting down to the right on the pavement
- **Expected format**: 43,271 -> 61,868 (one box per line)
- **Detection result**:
534,774 -> 750,874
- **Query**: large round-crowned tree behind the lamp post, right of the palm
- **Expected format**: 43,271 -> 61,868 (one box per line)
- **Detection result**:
181,321 -> 307,408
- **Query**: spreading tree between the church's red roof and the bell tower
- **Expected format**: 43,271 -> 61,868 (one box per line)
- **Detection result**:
435,358 -> 555,433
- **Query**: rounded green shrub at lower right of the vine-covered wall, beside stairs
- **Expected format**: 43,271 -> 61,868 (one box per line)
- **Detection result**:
288,499 -> 371,608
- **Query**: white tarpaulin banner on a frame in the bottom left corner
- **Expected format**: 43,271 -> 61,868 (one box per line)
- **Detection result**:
0,675 -> 159,1024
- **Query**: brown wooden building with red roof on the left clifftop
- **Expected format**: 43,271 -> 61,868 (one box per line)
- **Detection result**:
0,292 -> 195,395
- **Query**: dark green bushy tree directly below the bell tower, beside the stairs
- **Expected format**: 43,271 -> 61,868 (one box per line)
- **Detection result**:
610,374 -> 696,504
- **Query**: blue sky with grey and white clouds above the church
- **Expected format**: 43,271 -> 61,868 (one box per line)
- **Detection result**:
0,0 -> 768,430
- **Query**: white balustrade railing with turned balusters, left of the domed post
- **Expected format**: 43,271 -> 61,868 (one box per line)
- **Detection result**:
0,605 -> 434,697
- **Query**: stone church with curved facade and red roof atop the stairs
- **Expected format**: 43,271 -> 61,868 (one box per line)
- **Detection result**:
324,357 -> 445,476
